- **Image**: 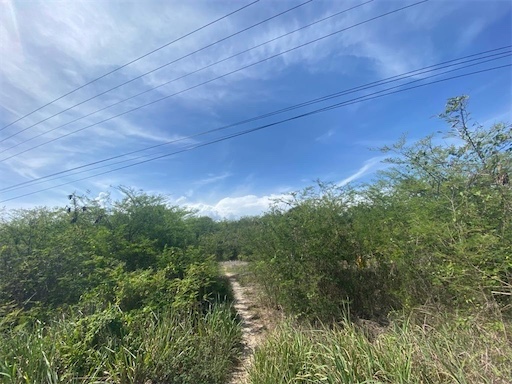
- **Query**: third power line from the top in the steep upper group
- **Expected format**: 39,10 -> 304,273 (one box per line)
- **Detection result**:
0,0 -> 374,154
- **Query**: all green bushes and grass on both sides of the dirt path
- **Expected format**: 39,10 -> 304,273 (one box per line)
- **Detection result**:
0,97 -> 512,384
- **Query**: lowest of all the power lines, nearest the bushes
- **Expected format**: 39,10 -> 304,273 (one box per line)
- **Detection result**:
0,64 -> 512,203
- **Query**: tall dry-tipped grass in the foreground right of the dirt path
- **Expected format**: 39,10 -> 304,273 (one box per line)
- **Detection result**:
249,315 -> 512,384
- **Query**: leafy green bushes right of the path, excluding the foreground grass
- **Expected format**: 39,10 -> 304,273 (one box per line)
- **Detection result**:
242,97 -> 512,320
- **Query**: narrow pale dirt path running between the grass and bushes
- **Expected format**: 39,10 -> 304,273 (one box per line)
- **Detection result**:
221,261 -> 270,384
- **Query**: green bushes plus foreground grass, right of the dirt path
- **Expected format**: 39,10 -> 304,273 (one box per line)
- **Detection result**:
217,97 -> 512,384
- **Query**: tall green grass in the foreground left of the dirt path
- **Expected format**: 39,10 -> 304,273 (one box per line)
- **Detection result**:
0,305 -> 241,384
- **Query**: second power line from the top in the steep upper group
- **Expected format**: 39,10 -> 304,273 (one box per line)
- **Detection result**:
0,0 -> 313,143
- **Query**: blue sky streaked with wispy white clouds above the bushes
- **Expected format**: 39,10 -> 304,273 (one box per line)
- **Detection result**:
0,0 -> 512,219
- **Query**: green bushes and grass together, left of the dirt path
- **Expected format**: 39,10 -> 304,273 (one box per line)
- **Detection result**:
0,189 -> 241,384
